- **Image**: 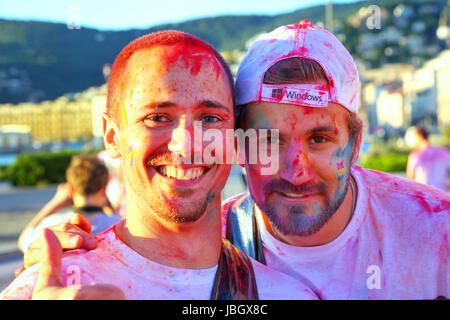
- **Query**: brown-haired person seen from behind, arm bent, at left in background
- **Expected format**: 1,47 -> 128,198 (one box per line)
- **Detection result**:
18,155 -> 120,252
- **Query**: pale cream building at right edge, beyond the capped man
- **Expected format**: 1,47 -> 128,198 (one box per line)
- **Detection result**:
361,50 -> 450,133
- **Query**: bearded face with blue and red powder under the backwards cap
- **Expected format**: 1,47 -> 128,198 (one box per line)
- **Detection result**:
244,102 -> 354,236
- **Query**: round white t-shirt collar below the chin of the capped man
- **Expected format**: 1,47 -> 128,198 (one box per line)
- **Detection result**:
255,167 -> 367,260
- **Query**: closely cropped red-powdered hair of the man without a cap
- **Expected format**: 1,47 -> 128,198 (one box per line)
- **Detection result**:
106,30 -> 235,124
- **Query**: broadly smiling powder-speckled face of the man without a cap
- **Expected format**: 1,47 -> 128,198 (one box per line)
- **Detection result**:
110,45 -> 234,223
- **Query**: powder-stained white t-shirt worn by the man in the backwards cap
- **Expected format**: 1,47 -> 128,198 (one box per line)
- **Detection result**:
251,166 -> 450,299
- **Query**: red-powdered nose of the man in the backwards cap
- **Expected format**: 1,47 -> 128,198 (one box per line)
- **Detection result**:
280,141 -> 312,185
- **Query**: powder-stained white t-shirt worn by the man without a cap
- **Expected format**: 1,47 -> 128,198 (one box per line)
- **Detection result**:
0,228 -> 317,300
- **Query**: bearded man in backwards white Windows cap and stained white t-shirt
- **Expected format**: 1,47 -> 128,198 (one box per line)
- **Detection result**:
12,21 -> 450,299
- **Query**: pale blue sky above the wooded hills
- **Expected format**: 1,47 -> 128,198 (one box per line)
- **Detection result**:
0,0 -> 356,30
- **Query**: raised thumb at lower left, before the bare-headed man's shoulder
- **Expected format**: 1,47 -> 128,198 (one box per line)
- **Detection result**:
35,228 -> 64,291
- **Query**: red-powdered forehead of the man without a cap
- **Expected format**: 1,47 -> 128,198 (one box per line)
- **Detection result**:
121,45 -> 232,116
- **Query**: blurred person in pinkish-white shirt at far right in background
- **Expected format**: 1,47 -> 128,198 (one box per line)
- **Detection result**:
406,126 -> 450,191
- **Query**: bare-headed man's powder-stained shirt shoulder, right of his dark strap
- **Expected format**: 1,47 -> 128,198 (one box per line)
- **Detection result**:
249,258 -> 318,300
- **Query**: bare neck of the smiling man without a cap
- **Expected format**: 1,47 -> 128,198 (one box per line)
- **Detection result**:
115,192 -> 222,269
